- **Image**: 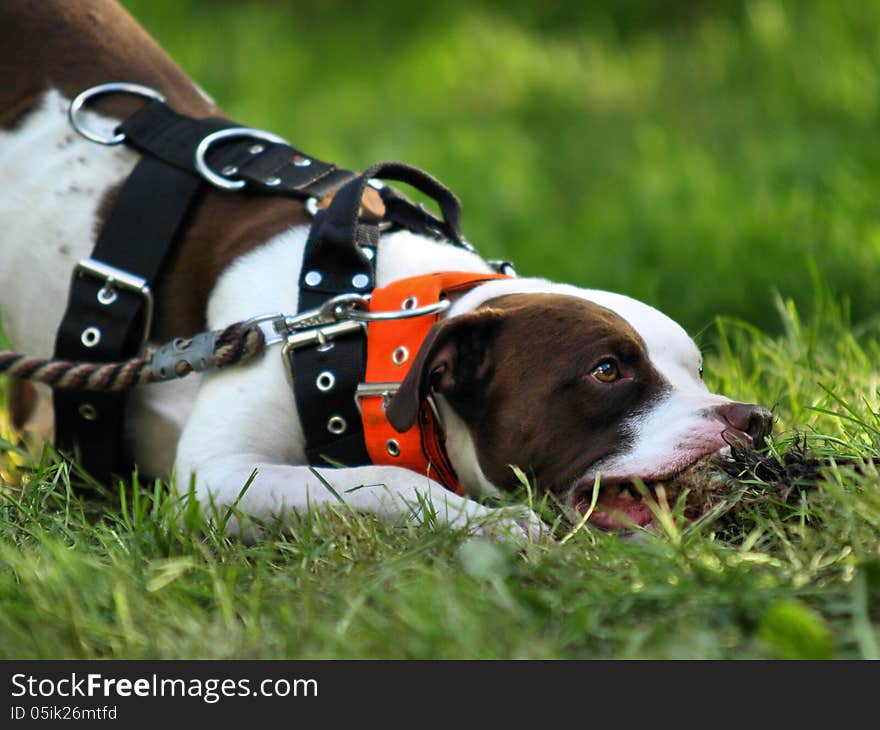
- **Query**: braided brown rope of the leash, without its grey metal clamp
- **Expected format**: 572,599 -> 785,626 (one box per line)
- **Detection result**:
0,322 -> 265,392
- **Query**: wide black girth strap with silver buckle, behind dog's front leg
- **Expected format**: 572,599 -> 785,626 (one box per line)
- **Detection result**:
54,157 -> 201,480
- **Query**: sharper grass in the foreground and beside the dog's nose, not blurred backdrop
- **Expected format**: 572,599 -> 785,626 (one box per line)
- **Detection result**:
0,292 -> 880,658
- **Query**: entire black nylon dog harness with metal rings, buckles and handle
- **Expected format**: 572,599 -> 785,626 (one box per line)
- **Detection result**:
54,84 -> 488,482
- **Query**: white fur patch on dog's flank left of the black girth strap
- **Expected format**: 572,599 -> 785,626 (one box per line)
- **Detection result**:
0,91 -> 137,357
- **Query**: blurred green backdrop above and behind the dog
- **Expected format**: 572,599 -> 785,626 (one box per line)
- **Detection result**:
124,0 -> 880,332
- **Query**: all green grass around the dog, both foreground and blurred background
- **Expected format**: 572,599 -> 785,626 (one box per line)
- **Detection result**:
0,0 -> 880,659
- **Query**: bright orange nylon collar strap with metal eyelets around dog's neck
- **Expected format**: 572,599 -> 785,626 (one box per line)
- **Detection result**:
360,271 -> 509,494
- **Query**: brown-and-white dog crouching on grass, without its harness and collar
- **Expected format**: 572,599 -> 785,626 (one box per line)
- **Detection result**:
0,0 -> 772,535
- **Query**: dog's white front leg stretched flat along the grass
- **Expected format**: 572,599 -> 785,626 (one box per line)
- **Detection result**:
176,354 -> 542,539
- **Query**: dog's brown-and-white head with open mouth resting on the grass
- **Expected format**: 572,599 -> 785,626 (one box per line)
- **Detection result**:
387,280 -> 772,528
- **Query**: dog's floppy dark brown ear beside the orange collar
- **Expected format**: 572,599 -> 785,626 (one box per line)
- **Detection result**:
385,309 -> 502,433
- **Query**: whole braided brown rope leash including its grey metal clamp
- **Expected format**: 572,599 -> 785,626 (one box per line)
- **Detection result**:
0,322 -> 266,392
